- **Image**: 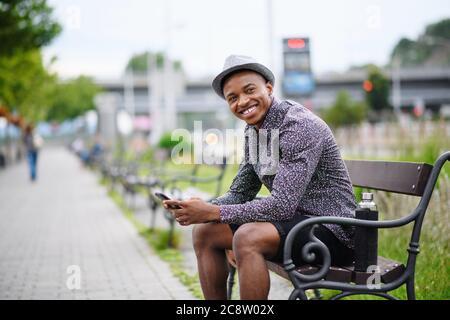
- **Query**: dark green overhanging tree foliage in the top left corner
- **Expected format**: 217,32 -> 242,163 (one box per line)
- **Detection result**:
0,0 -> 61,56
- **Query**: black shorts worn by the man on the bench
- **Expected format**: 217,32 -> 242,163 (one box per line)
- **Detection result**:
229,215 -> 354,266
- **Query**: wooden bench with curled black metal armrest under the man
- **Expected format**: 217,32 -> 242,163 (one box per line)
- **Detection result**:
227,151 -> 450,300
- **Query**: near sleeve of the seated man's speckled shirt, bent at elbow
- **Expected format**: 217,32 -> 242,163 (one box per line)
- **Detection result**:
220,117 -> 325,224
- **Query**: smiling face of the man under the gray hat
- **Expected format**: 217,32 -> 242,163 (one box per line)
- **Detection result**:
223,70 -> 273,129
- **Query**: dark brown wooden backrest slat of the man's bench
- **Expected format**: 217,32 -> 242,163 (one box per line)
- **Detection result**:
345,160 -> 433,196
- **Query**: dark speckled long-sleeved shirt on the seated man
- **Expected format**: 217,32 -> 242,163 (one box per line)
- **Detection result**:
212,98 -> 356,248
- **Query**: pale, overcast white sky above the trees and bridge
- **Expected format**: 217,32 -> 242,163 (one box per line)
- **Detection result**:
43,0 -> 450,79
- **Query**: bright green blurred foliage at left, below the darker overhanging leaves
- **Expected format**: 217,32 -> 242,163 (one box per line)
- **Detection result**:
0,50 -> 100,122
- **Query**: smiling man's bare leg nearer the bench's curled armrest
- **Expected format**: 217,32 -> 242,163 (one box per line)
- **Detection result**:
233,222 -> 280,300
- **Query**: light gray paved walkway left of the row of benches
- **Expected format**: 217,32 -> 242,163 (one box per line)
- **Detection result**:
0,147 -> 194,299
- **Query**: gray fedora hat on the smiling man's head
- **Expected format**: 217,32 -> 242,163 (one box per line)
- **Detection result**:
212,55 -> 275,99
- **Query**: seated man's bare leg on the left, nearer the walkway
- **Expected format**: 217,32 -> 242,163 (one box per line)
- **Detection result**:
192,223 -> 233,300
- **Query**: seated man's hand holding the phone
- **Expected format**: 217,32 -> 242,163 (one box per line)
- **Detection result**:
163,198 -> 220,226
